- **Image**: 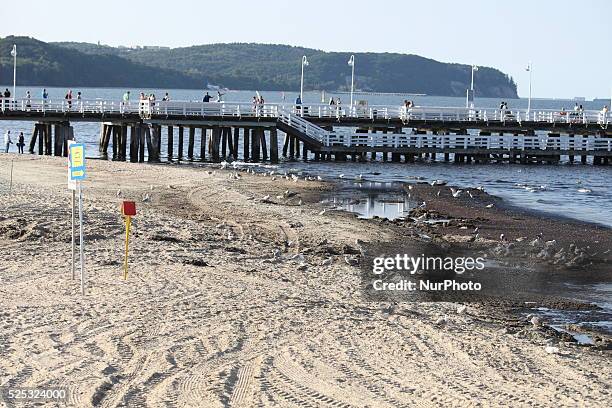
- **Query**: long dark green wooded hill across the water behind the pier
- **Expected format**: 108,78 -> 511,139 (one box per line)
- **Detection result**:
0,37 -> 517,98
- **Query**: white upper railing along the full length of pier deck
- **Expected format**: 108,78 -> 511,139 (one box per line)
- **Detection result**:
0,98 -> 612,127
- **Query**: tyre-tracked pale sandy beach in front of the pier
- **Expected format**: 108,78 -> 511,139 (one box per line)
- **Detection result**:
0,154 -> 612,407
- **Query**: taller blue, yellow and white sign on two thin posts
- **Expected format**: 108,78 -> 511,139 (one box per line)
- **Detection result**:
68,141 -> 85,295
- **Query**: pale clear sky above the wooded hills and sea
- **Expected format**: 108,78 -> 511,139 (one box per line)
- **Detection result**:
0,0 -> 612,99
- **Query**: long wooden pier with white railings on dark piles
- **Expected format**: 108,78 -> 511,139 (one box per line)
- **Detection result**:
0,100 -> 612,164
